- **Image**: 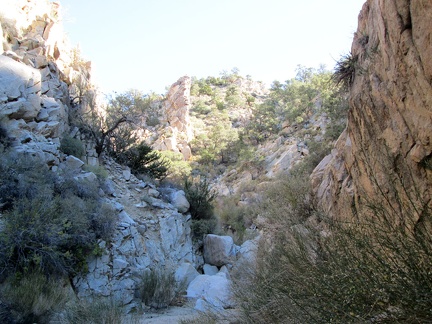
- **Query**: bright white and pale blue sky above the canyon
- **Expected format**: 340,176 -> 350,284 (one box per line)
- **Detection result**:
60,0 -> 365,94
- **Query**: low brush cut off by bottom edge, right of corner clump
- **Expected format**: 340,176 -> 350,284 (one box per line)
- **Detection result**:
62,299 -> 126,324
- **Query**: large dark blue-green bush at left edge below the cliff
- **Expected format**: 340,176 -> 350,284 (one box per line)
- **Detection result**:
0,155 -> 116,279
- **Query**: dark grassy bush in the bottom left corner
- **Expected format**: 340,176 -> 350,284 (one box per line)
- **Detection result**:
0,273 -> 68,323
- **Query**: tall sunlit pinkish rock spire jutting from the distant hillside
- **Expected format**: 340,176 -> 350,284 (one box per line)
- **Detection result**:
153,76 -> 193,160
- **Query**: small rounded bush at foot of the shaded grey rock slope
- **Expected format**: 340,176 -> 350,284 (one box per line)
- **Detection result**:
137,269 -> 178,309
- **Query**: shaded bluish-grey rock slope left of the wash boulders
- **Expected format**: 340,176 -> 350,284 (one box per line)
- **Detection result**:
74,161 -> 198,310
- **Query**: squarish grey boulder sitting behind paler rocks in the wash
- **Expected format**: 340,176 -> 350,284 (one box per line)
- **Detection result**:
204,234 -> 236,267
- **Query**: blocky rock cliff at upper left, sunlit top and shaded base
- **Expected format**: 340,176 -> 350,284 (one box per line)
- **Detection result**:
0,0 -> 88,165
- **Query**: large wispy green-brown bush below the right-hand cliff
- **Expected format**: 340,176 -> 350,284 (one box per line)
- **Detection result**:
234,151 -> 432,323
